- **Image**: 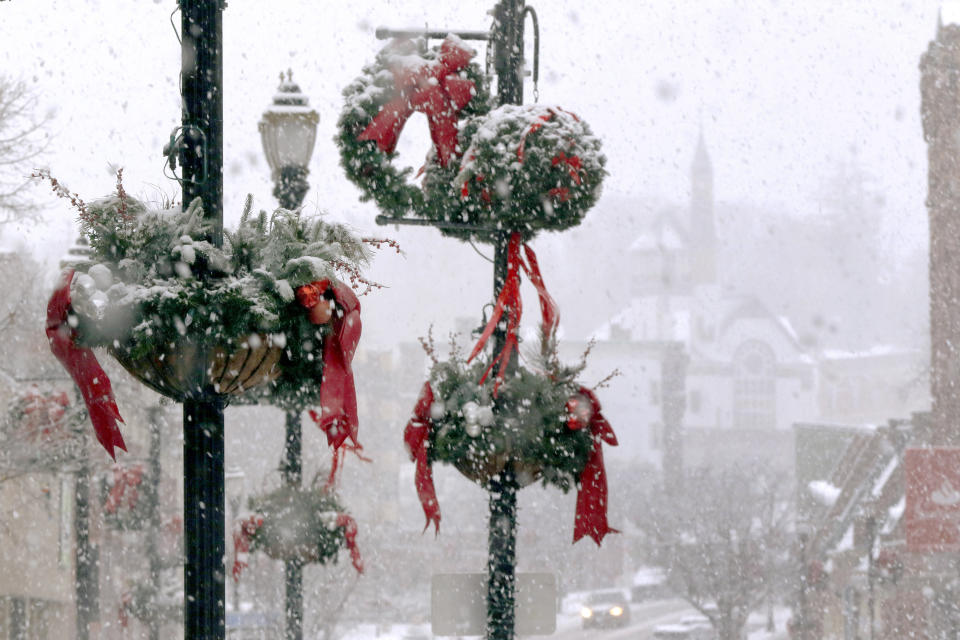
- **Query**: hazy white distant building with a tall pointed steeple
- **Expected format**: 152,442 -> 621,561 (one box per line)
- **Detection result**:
564,134 -> 818,467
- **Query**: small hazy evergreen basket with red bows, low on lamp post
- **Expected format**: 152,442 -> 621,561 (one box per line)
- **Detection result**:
233,486 -> 363,579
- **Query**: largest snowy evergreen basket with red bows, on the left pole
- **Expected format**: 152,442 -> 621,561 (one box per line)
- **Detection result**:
39,174 -> 386,455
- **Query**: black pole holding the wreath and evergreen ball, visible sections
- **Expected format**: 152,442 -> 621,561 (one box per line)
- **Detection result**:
487,0 -> 524,640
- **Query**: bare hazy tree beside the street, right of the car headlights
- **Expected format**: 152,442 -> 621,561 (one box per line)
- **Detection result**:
641,465 -> 790,640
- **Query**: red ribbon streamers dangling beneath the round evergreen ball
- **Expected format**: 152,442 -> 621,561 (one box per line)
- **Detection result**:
467,231 -> 560,396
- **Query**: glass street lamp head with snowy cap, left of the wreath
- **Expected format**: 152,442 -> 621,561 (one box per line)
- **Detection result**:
258,70 -> 320,209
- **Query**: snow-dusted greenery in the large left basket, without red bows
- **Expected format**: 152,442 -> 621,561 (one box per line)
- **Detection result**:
36,173 -> 399,407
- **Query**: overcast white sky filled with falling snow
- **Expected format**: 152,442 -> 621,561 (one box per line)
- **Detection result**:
0,0 -> 938,348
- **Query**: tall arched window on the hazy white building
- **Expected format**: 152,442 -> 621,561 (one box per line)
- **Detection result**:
733,340 -> 777,429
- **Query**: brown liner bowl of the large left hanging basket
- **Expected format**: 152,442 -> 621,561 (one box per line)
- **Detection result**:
110,334 -> 283,402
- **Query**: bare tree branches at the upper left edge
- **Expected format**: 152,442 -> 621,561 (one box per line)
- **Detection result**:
0,76 -> 49,226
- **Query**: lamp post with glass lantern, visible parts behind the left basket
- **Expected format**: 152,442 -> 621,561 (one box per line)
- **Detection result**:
258,71 -> 320,640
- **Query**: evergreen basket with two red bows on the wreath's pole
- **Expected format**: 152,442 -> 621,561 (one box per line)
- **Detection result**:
404,300 -> 617,544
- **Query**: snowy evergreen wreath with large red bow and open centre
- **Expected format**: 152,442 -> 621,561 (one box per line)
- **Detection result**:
336,35 -> 489,230
